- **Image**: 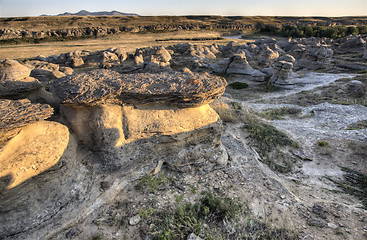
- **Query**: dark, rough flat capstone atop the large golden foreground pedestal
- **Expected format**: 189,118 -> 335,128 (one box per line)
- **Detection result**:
50,69 -> 227,107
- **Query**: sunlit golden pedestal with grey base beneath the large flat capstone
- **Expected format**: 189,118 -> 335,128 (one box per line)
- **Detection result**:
61,104 -> 227,171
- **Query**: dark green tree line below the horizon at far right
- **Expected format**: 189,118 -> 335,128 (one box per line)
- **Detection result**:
258,24 -> 367,38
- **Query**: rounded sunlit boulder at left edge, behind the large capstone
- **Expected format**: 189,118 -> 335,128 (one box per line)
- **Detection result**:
0,60 -> 42,98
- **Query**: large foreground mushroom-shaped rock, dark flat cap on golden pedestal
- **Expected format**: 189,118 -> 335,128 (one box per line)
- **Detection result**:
51,70 -> 226,169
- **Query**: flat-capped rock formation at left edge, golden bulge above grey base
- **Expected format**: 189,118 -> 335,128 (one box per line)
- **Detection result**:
0,99 -> 75,239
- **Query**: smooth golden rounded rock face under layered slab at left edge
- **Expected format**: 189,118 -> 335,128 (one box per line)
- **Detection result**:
0,121 -> 69,191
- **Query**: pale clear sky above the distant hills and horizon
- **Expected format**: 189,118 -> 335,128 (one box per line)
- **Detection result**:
0,0 -> 367,17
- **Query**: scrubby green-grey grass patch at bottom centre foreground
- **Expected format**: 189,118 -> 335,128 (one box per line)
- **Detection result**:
150,191 -> 300,240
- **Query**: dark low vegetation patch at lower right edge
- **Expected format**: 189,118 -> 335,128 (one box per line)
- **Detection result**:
327,167 -> 367,210
